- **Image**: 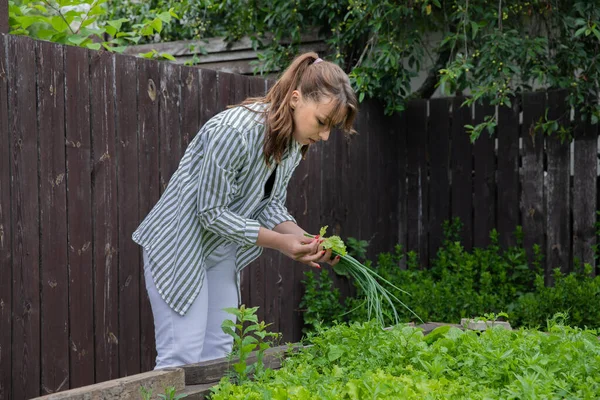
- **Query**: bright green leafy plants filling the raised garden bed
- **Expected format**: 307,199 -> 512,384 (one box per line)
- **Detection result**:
212,317 -> 600,400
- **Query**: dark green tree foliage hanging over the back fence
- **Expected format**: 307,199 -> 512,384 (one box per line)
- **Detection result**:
11,0 -> 600,139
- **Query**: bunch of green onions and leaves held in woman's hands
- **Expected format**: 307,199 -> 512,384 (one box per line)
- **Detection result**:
306,226 -> 423,326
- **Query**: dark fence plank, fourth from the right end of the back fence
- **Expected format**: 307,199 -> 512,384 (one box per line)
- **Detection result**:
497,99 -> 520,248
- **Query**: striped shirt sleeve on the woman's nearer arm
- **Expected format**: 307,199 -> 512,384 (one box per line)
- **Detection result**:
196,126 -> 260,245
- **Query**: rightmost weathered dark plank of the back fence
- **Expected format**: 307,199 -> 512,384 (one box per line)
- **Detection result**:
573,108 -> 598,275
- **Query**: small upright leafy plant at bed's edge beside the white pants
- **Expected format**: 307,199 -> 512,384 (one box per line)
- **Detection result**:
221,304 -> 280,382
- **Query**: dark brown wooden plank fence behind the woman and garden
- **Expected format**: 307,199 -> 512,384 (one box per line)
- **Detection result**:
0,35 -> 598,399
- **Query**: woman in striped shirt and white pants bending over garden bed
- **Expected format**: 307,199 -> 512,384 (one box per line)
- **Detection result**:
133,53 -> 357,369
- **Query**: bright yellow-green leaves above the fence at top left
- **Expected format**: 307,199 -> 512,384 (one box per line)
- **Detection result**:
9,0 -> 178,59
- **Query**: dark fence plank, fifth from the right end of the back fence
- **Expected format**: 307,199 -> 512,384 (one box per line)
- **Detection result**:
473,104 -> 496,247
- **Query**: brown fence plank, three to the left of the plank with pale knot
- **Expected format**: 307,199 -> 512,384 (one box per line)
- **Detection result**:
65,46 -> 94,388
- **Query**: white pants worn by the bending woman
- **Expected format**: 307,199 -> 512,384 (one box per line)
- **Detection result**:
144,245 -> 238,369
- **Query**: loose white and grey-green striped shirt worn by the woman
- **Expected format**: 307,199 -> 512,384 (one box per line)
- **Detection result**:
133,104 -> 302,315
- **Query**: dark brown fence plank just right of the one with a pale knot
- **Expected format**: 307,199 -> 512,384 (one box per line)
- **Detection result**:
158,63 -> 182,194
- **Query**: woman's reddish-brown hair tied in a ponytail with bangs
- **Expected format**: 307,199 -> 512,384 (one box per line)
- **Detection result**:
241,52 -> 358,165
